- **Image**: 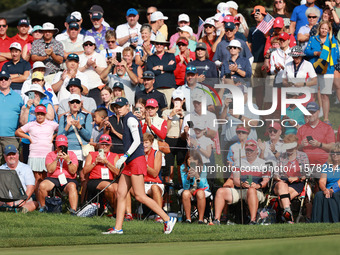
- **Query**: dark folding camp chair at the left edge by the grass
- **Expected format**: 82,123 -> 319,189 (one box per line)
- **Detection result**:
0,169 -> 27,212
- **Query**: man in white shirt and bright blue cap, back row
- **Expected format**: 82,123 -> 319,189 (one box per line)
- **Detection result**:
116,8 -> 142,48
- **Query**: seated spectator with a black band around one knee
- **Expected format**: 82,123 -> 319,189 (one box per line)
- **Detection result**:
273,134 -> 309,223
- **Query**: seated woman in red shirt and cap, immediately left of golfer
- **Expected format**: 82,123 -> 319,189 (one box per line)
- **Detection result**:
83,135 -> 119,212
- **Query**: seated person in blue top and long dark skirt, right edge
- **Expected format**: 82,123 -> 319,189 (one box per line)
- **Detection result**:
312,143 -> 340,222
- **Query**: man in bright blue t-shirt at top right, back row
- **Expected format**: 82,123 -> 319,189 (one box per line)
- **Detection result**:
289,0 -> 322,39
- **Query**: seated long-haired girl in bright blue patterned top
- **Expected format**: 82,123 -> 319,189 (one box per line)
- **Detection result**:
181,150 -> 211,224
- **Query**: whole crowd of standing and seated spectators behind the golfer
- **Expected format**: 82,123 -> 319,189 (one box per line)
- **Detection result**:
0,0 -> 340,224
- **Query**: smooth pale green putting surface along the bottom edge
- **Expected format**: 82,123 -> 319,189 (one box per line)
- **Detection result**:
0,235 -> 340,255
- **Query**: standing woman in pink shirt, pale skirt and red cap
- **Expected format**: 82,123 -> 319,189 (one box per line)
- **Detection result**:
15,105 -> 59,196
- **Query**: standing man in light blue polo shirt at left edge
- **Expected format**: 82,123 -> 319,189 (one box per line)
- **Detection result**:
0,69 -> 24,159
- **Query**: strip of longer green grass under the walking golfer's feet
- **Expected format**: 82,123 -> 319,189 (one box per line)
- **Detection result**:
0,212 -> 340,248
